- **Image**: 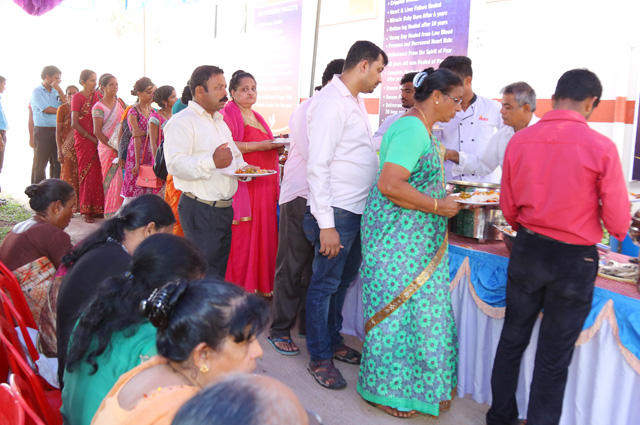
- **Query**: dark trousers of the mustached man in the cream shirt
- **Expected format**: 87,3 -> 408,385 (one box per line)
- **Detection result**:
178,194 -> 233,280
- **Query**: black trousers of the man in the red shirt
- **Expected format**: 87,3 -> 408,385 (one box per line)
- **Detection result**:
487,229 -> 598,425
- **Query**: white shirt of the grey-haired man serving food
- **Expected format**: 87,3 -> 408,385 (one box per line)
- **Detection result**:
451,115 -> 540,183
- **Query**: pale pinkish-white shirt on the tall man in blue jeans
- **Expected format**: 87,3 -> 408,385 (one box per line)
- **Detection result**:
307,75 -> 378,229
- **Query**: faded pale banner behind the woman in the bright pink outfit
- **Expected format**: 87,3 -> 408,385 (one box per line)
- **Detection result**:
252,0 -> 302,136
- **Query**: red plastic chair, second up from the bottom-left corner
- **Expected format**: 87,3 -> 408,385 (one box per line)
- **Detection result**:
0,332 -> 62,425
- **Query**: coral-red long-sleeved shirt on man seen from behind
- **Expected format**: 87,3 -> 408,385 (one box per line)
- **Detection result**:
500,110 -> 631,245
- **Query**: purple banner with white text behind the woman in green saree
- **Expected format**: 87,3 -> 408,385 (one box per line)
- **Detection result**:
380,0 -> 470,123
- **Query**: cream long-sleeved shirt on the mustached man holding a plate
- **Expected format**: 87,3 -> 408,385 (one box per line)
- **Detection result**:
164,100 -> 247,201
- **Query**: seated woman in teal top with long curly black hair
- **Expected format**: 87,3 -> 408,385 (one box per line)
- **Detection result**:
61,234 -> 207,425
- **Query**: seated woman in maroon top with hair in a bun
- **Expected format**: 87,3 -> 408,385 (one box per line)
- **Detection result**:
0,179 -> 76,323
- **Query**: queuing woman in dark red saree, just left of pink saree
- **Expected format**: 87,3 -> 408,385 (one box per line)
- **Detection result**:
71,69 -> 104,223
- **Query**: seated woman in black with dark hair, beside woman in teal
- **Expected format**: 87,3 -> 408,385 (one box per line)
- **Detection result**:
52,195 -> 175,386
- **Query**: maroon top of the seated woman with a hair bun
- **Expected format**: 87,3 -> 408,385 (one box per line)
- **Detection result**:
0,216 -> 71,270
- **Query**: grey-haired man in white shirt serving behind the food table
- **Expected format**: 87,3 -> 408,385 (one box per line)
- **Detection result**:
445,81 -> 540,183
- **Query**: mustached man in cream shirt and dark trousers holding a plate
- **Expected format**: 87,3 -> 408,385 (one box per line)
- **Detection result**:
164,65 -> 255,279
